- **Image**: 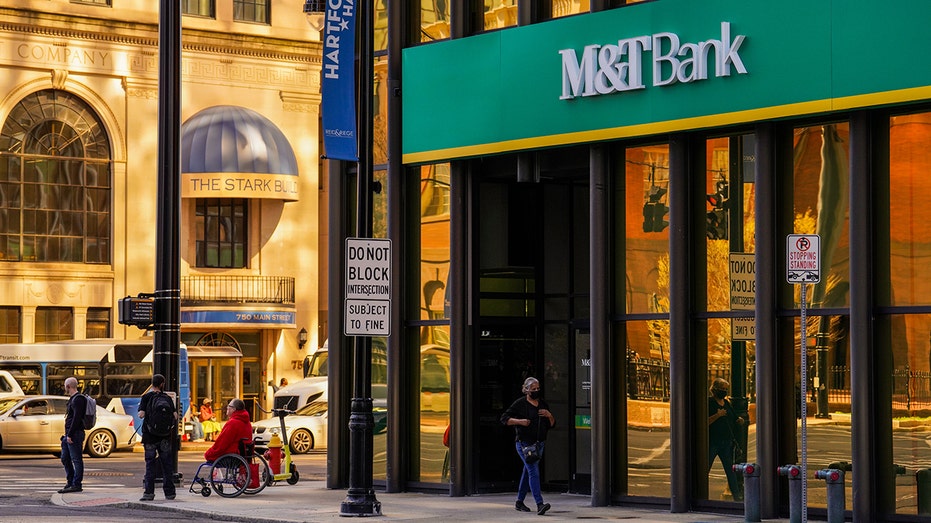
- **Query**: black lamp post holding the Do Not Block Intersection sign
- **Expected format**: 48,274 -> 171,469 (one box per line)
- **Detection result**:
304,0 -> 381,516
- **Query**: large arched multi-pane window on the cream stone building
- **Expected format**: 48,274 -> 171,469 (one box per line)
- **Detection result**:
0,89 -> 112,263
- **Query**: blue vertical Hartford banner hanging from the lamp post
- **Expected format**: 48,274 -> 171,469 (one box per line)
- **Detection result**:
321,0 -> 359,162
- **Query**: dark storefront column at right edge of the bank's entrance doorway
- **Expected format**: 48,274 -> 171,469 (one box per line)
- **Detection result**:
589,144 -> 620,507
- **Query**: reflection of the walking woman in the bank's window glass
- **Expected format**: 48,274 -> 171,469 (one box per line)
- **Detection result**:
708,378 -> 746,501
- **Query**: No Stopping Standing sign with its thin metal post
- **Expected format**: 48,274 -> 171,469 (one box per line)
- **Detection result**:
786,234 -> 821,523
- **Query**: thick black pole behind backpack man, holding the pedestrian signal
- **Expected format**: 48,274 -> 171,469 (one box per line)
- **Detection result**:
152,0 -> 181,484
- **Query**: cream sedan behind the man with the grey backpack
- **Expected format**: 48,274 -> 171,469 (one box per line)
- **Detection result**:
0,396 -> 135,458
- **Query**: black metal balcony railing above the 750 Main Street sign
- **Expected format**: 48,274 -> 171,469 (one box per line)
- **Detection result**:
181,276 -> 294,305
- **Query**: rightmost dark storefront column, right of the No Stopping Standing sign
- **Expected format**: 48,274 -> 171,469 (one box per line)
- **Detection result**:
850,111 -> 895,521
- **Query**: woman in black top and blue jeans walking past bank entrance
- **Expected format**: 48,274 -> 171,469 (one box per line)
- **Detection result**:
501,377 -> 556,516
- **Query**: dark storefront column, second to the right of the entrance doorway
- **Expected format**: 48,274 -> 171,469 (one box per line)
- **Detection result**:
668,134 -> 695,512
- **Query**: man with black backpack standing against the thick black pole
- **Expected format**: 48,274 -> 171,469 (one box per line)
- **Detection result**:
139,374 -> 178,501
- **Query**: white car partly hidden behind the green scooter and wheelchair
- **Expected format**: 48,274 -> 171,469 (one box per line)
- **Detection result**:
252,401 -> 327,454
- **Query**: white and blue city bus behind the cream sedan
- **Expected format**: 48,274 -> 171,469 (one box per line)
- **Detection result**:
0,338 -> 191,434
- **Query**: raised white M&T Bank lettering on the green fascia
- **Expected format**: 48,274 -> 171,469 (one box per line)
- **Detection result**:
559,22 -> 747,100
